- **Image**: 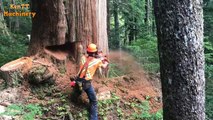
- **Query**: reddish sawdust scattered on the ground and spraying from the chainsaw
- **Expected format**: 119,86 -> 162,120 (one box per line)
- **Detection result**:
0,51 -> 162,119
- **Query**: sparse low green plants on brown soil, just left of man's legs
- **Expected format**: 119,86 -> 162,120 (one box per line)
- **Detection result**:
36,85 -> 72,120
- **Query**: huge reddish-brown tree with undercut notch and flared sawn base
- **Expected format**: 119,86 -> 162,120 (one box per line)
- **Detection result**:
0,0 -> 108,86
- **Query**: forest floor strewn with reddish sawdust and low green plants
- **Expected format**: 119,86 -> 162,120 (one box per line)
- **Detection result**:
0,51 -> 162,120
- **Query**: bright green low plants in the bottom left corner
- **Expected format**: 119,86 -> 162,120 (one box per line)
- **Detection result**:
0,104 -> 42,120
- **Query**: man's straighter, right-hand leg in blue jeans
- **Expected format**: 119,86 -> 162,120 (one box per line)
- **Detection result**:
85,85 -> 98,120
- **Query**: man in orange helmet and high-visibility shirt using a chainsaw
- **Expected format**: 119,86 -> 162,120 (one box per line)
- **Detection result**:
71,44 -> 109,120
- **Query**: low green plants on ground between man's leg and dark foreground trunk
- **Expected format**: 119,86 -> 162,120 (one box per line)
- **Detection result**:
98,94 -> 163,120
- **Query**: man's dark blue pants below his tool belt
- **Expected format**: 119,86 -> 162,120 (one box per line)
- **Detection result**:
73,79 -> 98,120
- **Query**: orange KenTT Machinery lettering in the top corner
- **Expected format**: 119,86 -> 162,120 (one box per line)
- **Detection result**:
0,4 -> 36,18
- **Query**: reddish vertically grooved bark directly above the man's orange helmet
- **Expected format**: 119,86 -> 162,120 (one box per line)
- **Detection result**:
66,0 -> 97,48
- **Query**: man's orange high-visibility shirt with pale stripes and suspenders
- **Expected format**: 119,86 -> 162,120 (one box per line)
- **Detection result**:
80,56 -> 102,80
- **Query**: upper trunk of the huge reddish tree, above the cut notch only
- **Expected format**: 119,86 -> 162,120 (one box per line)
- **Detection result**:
29,0 -> 108,56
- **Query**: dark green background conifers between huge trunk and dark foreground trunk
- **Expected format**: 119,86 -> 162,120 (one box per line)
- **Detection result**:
109,0 -> 155,49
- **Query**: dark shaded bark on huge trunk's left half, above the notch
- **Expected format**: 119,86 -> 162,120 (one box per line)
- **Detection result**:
28,0 -> 66,55
